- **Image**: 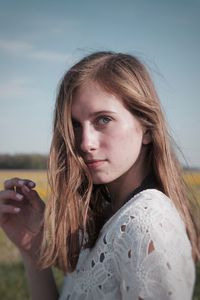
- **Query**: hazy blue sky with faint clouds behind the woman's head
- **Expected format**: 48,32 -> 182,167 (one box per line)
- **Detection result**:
0,0 -> 200,167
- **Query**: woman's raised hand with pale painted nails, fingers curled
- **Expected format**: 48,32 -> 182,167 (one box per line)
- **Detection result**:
0,178 -> 45,259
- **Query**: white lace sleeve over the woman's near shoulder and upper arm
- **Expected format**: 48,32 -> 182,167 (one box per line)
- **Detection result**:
115,190 -> 195,300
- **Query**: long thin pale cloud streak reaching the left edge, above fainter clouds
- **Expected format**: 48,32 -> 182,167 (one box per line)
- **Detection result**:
0,39 -> 72,63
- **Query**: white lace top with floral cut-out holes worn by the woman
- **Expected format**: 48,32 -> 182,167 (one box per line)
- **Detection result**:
60,189 -> 195,300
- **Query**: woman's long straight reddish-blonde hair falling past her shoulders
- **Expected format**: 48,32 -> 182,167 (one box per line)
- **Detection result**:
40,52 -> 200,272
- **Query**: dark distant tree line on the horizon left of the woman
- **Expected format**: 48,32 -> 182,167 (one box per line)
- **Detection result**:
0,154 -> 48,170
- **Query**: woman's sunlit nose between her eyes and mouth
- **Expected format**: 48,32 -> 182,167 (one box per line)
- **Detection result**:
80,126 -> 98,153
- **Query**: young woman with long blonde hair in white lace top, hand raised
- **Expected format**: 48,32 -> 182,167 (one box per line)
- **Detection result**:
0,52 -> 200,300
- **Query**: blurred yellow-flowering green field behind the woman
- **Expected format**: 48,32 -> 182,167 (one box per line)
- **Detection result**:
0,170 -> 200,300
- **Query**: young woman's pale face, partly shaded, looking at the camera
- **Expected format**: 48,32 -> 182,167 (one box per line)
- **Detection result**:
72,82 -> 149,188
